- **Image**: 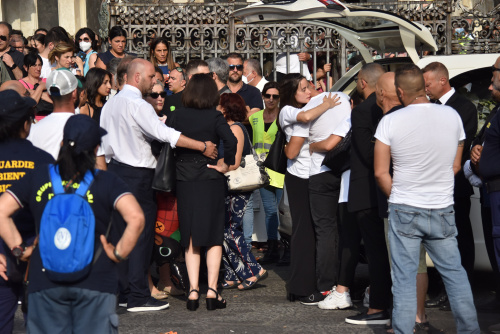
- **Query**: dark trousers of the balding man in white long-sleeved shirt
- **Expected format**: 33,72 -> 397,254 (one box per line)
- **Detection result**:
108,161 -> 156,308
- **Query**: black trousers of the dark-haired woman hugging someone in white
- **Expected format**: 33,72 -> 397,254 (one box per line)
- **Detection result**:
285,172 -> 317,296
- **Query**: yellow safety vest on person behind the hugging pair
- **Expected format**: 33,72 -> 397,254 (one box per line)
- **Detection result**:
248,110 -> 285,188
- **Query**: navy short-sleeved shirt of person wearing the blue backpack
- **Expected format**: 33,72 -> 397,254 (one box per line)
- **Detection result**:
7,165 -> 130,293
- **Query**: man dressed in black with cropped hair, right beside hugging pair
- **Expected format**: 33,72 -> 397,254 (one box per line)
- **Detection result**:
345,63 -> 392,325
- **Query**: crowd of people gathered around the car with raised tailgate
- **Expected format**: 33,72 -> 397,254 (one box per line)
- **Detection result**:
0,22 -> 500,334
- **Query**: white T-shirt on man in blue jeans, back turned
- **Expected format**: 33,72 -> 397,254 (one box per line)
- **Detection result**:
375,103 -> 465,209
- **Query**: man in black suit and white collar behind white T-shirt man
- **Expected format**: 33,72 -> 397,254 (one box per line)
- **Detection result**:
422,62 -> 477,311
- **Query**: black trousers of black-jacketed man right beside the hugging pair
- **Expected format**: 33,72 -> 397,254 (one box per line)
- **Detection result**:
355,208 -> 392,310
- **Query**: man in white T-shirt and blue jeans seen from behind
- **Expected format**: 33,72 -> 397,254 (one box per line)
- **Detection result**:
375,65 -> 480,334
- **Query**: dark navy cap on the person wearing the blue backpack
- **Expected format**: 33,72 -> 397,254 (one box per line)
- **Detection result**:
63,114 -> 108,154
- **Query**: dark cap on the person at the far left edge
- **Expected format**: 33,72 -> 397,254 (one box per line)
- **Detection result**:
0,89 -> 36,122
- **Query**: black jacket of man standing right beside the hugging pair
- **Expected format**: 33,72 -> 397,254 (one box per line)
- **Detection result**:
347,93 -> 383,212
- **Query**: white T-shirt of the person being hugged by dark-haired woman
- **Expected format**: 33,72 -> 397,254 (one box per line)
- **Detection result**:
307,92 -> 351,176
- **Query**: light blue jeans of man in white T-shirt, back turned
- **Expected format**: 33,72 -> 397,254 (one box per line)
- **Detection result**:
388,203 -> 480,334
